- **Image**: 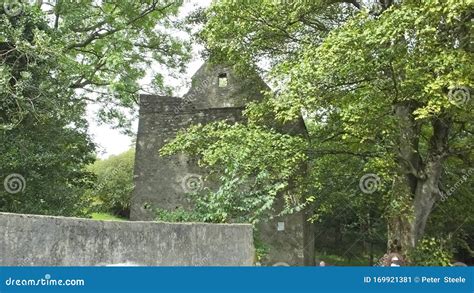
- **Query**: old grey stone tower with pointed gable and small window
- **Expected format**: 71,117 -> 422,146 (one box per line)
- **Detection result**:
130,62 -> 314,265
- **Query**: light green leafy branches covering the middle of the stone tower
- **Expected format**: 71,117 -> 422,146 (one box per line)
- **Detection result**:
161,122 -> 307,223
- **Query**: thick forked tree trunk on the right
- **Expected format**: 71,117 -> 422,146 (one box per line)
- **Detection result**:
388,102 -> 451,254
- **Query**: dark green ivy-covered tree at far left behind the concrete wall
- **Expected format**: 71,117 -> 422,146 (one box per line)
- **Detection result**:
0,6 -> 94,216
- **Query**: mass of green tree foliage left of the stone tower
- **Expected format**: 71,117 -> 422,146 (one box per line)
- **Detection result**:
0,1 -> 189,215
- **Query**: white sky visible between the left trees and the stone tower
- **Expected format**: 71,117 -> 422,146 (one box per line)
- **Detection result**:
88,0 -> 211,158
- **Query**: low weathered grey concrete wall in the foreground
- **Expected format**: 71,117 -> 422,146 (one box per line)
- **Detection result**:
0,213 -> 254,266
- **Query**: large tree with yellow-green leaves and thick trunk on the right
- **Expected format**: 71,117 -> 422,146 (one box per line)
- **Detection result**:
180,0 -> 473,252
